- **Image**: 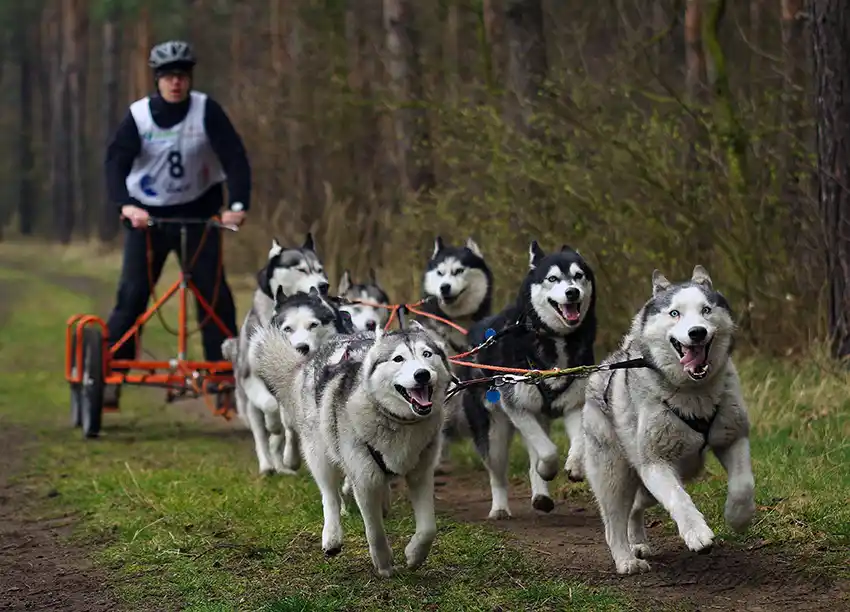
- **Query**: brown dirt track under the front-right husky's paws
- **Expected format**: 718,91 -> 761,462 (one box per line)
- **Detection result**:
437,471 -> 850,612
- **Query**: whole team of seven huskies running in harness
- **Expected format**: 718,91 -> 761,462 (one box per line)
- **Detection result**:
224,234 -> 755,576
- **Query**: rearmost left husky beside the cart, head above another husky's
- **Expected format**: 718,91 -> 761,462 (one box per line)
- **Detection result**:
230,232 -> 329,474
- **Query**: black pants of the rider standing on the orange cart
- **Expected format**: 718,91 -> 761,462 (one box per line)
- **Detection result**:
107,224 -> 236,361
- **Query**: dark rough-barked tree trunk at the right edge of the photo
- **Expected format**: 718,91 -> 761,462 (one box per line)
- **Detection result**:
808,0 -> 850,359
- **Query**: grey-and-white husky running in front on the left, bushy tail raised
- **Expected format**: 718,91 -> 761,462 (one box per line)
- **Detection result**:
251,325 -> 450,577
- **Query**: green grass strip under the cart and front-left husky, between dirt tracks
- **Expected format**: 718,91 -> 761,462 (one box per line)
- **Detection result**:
0,243 -> 626,611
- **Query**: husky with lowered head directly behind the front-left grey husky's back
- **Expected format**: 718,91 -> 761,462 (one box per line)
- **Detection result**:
240,287 -> 353,474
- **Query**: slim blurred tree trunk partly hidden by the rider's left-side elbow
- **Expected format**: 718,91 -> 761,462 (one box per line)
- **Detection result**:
98,11 -> 121,242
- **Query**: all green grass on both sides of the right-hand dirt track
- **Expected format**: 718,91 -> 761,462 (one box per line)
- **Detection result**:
0,241 -> 850,612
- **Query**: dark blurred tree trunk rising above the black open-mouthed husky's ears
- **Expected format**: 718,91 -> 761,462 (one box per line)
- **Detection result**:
505,0 -> 548,134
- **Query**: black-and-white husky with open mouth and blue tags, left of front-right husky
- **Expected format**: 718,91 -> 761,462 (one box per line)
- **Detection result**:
463,240 -> 596,519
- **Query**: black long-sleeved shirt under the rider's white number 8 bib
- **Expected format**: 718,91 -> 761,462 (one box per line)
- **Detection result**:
105,94 -> 251,217
